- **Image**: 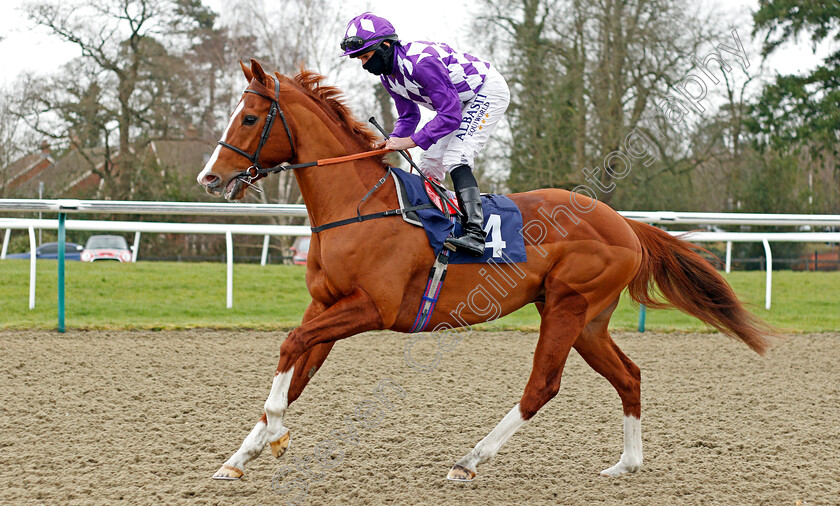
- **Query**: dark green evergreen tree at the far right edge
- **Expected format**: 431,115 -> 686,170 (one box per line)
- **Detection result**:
750,0 -> 840,213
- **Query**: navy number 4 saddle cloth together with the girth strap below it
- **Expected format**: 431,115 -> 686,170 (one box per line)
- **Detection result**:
391,168 -> 527,333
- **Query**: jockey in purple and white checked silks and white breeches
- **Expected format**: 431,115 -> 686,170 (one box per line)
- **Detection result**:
341,12 -> 510,256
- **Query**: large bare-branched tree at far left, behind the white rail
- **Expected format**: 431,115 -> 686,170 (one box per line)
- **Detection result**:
19,0 -> 218,196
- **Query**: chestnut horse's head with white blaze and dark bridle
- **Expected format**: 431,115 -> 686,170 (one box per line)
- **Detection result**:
197,60 -> 295,200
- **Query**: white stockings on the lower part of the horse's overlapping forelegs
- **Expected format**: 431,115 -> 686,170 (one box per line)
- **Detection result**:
225,367 -> 295,471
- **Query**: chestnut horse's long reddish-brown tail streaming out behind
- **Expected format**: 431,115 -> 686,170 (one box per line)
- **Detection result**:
627,219 -> 778,355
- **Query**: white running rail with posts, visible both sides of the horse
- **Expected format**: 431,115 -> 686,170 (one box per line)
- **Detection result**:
0,199 -> 840,332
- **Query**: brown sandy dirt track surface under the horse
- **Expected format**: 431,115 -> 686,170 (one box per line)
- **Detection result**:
0,331 -> 840,505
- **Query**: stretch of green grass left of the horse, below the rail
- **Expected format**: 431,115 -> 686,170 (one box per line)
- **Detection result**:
0,260 -> 310,329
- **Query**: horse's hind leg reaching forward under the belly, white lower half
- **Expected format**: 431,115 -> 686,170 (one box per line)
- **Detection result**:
447,281 -> 587,481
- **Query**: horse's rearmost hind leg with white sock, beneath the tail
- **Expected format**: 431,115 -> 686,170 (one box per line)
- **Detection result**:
574,299 -> 642,476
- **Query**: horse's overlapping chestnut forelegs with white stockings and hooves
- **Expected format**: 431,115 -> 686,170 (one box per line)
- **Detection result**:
213,290 -> 382,479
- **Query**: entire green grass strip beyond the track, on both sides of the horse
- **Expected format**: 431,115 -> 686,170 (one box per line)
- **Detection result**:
0,260 -> 840,332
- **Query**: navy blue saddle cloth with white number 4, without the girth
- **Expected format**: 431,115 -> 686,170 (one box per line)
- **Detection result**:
391,168 -> 527,264
